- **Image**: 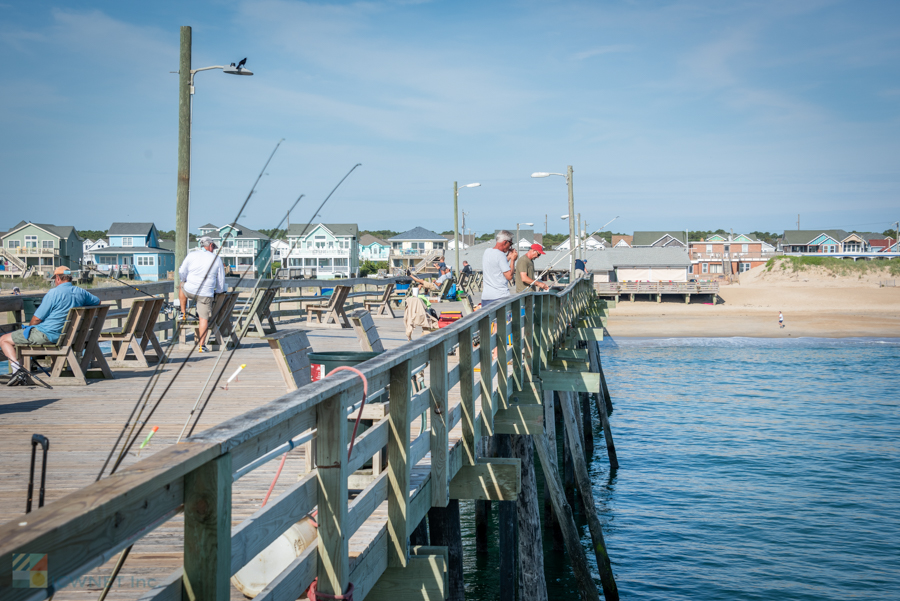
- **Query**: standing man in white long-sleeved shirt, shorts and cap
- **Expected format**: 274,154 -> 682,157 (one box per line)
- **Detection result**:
178,236 -> 225,346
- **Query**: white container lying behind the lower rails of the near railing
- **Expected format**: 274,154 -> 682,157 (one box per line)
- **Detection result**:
231,519 -> 316,599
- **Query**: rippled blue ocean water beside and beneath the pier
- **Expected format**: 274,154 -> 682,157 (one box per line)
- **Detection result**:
462,338 -> 900,601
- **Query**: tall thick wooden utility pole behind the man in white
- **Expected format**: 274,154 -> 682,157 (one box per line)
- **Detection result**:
175,25 -> 191,294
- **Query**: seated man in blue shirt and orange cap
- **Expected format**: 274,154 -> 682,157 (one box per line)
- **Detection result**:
0,266 -> 100,386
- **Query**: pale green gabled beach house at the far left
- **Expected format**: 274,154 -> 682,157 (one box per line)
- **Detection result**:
0,221 -> 84,275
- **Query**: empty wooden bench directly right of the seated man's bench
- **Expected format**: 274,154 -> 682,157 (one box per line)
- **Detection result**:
100,297 -> 166,367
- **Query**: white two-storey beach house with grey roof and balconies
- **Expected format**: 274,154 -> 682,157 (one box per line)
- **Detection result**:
284,223 -> 359,280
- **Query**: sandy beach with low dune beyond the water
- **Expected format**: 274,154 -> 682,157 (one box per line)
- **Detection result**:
607,267 -> 900,338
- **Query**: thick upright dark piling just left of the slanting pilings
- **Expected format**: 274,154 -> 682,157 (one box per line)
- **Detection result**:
510,435 -> 547,601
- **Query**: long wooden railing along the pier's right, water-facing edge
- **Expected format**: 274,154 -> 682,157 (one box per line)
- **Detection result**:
0,280 -> 593,601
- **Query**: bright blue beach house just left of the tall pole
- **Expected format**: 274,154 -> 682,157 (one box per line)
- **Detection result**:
92,223 -> 175,282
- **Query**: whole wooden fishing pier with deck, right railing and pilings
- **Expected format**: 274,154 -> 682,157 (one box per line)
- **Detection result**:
0,280 -> 618,601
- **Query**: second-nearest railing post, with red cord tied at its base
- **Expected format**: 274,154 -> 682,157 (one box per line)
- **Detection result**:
316,394 -> 350,595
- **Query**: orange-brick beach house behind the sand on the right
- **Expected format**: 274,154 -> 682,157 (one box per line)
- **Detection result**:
690,234 -> 775,280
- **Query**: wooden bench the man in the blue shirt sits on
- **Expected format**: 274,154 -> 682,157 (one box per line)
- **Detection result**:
16,305 -> 114,386
